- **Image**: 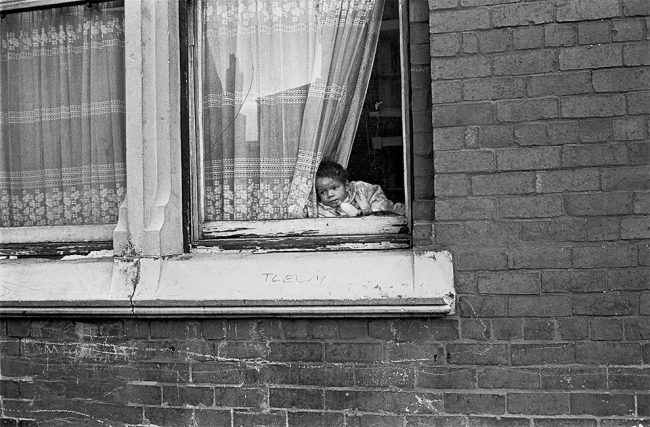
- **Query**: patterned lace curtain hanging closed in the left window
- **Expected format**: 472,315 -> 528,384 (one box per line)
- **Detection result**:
0,2 -> 126,227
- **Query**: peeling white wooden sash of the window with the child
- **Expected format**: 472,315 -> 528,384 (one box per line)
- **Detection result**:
187,0 -> 413,244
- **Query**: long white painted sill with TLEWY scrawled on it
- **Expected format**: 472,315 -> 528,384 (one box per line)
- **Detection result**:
0,250 -> 454,316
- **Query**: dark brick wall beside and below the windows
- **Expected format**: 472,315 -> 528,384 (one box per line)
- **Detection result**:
0,0 -> 650,427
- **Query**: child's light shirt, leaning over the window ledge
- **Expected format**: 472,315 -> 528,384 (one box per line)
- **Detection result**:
318,181 -> 405,218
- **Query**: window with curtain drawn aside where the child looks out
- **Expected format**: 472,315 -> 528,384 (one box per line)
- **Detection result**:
188,0 -> 411,249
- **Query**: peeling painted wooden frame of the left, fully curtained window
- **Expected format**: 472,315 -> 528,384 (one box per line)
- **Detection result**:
0,0 -> 125,256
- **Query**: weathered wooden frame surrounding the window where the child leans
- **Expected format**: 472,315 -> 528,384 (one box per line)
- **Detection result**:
180,0 -> 413,250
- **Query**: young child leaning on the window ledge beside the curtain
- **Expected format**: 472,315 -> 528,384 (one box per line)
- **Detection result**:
316,160 -> 404,217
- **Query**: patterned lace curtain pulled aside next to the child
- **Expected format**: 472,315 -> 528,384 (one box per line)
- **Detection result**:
200,0 -> 383,221
